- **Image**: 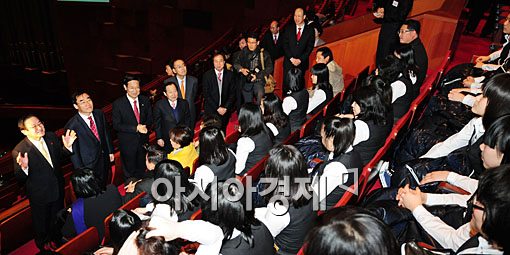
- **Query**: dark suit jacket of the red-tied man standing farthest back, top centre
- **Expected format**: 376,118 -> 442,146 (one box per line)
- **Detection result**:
283,24 -> 315,71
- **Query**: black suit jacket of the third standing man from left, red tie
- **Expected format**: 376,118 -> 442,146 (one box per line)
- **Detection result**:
112,95 -> 153,146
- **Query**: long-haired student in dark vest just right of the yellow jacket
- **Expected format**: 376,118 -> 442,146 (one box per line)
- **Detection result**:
191,127 -> 236,191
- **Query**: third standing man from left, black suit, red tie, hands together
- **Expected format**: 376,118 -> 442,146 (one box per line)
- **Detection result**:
112,75 -> 152,179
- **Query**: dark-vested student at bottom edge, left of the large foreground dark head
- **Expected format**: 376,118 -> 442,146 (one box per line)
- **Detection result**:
199,182 -> 274,255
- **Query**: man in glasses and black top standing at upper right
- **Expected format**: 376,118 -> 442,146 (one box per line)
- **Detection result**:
398,19 -> 429,86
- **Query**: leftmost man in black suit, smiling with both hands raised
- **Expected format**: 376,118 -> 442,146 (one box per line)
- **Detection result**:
12,115 -> 76,250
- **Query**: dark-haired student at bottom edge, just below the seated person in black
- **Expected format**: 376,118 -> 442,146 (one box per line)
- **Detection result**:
94,209 -> 142,255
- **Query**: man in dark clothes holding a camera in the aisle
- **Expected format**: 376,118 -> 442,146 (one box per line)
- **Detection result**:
234,33 -> 273,105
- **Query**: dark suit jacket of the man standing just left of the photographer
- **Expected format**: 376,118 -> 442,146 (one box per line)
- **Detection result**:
202,69 -> 235,113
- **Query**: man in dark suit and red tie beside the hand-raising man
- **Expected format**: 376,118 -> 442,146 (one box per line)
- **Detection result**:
64,91 -> 114,187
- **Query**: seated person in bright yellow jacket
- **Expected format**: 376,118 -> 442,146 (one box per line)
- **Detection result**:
168,127 -> 198,171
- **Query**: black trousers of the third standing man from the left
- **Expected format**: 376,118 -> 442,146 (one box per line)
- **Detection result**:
119,139 -> 145,179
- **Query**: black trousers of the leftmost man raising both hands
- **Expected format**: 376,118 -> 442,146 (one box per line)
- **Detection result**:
30,198 -> 64,250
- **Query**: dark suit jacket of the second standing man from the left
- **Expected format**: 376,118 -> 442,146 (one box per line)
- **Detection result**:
64,109 -> 114,169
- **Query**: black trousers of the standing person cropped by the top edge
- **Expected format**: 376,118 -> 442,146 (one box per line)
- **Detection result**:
375,22 -> 400,66
